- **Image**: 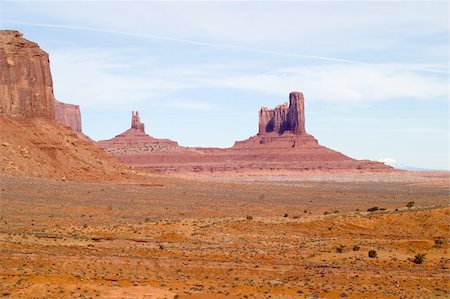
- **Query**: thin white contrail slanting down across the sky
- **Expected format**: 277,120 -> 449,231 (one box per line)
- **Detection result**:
3,20 -> 449,74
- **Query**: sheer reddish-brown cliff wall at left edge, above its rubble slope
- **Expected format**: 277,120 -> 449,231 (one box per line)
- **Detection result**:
0,30 -> 55,119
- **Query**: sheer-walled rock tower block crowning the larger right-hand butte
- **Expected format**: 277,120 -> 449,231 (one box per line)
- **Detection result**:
259,92 -> 306,135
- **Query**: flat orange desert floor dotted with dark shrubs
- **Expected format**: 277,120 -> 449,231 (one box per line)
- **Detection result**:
0,174 -> 450,298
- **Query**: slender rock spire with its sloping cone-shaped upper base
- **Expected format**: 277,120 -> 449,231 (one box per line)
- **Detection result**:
97,111 -> 178,153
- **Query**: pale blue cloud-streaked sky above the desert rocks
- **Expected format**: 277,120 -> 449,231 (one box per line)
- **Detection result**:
0,1 -> 450,170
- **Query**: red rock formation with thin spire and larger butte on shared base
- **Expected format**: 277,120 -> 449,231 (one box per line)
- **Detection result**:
98,92 -> 392,175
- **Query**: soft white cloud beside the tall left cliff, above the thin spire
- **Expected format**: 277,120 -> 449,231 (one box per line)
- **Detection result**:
50,49 -> 193,107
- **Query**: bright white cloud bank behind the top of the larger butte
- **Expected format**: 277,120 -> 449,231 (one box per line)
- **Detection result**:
211,64 -> 448,102
